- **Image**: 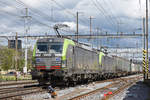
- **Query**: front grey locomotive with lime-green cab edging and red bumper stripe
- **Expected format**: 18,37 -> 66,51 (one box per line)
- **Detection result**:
32,38 -> 103,84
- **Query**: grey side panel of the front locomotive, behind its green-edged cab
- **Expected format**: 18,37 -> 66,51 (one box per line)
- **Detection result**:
74,47 -> 99,73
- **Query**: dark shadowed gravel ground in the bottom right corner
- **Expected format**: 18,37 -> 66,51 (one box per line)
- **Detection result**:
110,80 -> 150,100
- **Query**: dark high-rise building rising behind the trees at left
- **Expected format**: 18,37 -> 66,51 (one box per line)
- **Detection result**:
8,40 -> 22,49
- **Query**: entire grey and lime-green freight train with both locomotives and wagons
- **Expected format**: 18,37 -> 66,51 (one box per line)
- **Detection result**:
32,38 -> 142,85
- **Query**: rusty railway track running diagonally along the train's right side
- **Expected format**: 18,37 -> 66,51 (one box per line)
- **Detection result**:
51,76 -> 142,100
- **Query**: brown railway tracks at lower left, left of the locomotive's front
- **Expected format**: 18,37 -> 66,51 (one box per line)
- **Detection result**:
0,81 -> 45,100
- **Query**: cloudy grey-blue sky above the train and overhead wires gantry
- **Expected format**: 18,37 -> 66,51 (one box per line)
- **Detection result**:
0,0 -> 149,45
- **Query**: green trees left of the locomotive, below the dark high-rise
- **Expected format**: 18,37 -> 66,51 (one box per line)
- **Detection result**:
0,46 -> 32,71
